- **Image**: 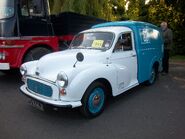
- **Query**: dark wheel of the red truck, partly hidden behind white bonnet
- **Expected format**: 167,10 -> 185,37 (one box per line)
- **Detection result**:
23,47 -> 51,63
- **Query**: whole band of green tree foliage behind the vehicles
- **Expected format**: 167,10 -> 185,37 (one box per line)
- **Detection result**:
49,0 -> 185,54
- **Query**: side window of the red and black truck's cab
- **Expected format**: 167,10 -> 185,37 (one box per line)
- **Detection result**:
20,0 -> 44,17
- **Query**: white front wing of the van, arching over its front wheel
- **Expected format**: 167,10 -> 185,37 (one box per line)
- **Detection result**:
64,64 -> 117,101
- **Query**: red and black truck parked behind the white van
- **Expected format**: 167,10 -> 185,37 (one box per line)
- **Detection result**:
0,0 -> 105,70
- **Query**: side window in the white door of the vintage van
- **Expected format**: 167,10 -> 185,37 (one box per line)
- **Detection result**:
114,32 -> 132,52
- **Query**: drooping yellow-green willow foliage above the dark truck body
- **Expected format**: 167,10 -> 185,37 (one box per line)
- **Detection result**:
50,0 -> 108,18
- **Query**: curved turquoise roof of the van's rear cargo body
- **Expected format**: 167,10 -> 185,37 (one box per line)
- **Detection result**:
92,21 -> 158,29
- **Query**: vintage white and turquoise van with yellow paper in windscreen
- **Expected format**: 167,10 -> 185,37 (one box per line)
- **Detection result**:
20,21 -> 163,117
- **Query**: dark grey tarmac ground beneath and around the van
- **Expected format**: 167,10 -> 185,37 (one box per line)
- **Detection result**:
0,62 -> 185,139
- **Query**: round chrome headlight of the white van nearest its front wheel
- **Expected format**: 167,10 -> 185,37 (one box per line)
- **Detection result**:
57,72 -> 68,87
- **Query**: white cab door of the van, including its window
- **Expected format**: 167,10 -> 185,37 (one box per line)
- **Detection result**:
111,32 -> 138,95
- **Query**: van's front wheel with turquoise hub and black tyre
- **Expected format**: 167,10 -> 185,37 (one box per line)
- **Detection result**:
80,82 -> 106,118
